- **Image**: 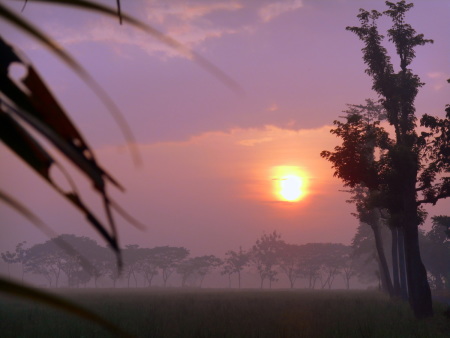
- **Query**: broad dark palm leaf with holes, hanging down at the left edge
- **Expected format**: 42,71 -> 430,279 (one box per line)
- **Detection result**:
0,39 -> 121,252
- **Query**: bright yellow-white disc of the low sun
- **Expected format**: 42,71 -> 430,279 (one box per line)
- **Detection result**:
272,166 -> 307,202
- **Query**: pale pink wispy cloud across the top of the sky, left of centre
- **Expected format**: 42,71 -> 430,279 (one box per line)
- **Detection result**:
47,1 -> 245,58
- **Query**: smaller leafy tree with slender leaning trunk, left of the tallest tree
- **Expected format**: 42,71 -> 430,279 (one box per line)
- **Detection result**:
321,99 -> 397,296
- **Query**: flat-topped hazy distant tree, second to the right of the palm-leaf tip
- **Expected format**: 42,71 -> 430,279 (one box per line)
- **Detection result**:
154,246 -> 189,286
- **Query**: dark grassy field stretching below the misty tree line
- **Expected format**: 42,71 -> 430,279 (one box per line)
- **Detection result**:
0,289 -> 450,338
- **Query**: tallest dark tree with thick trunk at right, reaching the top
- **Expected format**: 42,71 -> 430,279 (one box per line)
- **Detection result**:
322,1 -> 450,318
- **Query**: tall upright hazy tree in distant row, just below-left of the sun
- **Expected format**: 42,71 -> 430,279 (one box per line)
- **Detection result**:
250,231 -> 283,288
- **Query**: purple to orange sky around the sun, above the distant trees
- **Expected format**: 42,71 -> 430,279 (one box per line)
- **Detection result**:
0,0 -> 450,255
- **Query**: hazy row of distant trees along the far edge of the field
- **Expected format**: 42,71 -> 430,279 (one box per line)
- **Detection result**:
1,228 -> 450,289
